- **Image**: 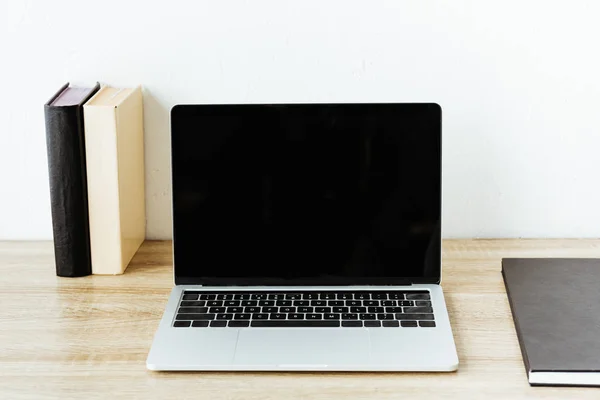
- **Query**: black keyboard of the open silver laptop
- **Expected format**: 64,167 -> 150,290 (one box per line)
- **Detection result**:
173,290 -> 435,328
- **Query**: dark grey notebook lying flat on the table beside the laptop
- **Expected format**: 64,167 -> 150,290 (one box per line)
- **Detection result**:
502,258 -> 600,386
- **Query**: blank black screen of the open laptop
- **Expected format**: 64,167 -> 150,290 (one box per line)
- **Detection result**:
171,104 -> 441,285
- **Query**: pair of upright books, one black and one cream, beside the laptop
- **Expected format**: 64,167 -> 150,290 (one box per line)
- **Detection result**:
44,84 -> 146,277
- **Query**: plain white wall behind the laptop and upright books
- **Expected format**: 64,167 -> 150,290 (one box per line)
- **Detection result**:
0,0 -> 600,239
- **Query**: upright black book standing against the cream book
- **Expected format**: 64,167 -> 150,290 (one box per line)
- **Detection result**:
44,83 -> 100,277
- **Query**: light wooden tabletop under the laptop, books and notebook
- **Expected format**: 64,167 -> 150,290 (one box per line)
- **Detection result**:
0,240 -> 600,400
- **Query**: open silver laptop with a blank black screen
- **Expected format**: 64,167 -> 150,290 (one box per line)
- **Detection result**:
147,104 -> 458,371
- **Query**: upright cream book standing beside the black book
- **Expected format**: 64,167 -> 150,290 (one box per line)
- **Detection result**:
83,86 -> 146,275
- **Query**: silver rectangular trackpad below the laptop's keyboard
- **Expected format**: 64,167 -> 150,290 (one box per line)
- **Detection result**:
234,328 -> 370,369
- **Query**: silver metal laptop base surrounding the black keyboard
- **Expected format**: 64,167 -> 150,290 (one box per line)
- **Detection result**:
146,285 -> 458,371
